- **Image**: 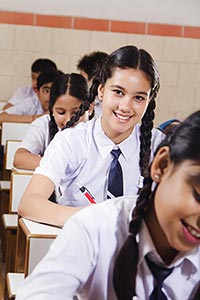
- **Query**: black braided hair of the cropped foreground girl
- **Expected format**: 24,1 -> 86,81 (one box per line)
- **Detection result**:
113,111 -> 200,300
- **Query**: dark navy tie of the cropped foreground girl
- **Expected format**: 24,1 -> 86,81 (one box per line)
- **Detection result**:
145,256 -> 174,300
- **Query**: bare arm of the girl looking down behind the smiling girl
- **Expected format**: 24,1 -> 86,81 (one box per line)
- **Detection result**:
13,148 -> 42,170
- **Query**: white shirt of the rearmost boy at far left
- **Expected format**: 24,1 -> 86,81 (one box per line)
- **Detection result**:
8,86 -> 38,105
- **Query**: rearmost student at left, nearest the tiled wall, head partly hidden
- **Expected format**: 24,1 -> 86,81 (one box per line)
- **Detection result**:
3,58 -> 57,110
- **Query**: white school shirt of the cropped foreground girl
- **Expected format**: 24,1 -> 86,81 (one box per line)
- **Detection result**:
15,196 -> 200,300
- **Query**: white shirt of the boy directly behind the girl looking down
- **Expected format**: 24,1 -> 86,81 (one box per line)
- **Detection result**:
4,97 -> 44,116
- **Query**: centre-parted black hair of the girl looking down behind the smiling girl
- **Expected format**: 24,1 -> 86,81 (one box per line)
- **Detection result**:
49,73 -> 88,141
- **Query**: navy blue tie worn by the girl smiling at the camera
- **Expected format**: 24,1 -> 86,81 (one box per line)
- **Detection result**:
107,149 -> 123,198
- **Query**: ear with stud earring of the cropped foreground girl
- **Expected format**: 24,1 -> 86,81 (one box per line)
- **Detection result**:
151,146 -> 170,182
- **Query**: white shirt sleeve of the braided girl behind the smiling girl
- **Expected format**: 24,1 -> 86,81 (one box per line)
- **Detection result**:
20,115 -> 50,156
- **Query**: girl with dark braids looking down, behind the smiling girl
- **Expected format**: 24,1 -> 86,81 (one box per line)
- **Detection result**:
13,73 -> 92,170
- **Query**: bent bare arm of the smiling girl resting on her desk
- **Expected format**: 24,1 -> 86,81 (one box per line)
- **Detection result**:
18,174 -> 81,226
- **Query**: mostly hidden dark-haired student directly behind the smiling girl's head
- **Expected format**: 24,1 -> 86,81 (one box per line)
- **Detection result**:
77,51 -> 108,117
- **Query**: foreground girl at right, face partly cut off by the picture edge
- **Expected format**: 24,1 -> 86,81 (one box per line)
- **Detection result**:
16,111 -> 200,300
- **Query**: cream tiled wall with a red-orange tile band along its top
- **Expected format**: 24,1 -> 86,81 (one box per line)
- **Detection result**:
0,12 -> 200,124
